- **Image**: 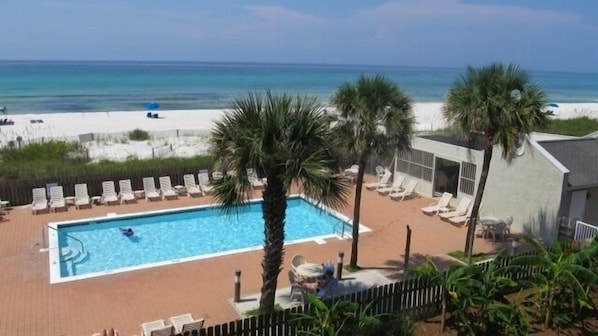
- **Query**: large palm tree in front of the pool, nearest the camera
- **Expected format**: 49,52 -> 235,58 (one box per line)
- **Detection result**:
212,91 -> 349,314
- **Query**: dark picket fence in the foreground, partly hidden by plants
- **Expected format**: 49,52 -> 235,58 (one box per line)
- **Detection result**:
188,251 -> 541,336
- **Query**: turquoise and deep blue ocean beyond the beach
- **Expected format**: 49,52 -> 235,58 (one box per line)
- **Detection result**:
0,61 -> 598,114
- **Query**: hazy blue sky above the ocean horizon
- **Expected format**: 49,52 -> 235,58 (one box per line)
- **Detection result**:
0,0 -> 598,73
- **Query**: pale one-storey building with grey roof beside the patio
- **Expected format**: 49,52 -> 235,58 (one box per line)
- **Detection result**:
396,133 -> 598,241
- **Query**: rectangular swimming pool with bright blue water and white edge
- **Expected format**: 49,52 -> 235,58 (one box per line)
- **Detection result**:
48,195 -> 369,283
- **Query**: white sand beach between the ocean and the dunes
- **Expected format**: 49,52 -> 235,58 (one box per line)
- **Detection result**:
0,103 -> 598,160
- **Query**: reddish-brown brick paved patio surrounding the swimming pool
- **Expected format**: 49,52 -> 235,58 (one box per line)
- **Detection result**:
0,181 -> 507,336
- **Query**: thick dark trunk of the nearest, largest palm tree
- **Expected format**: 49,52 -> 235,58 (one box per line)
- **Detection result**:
260,174 -> 287,314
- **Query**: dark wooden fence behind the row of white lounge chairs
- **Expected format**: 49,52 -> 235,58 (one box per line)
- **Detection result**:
0,167 -> 206,206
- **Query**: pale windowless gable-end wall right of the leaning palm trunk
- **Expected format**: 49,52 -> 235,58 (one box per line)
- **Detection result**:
481,141 -> 569,242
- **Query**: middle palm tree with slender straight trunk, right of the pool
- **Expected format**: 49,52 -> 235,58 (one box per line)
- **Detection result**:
331,76 -> 414,267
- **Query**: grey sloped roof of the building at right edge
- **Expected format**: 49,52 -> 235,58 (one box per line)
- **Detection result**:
539,138 -> 598,188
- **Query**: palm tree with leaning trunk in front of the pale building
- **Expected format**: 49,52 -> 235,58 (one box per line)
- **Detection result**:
443,63 -> 550,261
